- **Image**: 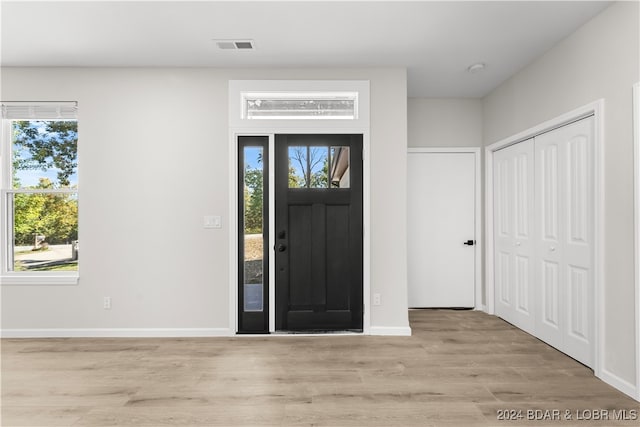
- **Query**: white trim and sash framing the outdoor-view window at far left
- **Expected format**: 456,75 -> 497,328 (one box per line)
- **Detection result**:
0,102 -> 80,286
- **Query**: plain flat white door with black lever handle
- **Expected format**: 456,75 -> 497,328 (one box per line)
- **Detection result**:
408,152 -> 477,307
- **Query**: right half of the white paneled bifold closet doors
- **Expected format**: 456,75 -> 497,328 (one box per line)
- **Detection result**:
535,117 -> 594,366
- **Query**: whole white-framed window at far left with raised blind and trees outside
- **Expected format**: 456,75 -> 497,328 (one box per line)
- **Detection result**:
0,102 -> 79,284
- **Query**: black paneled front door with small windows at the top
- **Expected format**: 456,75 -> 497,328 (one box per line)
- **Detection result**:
275,135 -> 363,331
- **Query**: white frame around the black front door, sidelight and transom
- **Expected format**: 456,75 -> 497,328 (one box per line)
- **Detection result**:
229,80 -> 372,337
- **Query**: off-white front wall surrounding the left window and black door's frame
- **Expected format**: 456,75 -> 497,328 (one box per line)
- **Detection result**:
2,68 -> 408,334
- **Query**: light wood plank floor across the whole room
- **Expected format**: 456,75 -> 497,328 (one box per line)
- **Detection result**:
1,310 -> 640,427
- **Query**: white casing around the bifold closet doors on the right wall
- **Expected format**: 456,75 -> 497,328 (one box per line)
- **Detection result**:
485,99 -> 604,378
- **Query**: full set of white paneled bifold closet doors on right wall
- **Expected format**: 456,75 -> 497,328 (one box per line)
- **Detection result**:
493,117 -> 595,366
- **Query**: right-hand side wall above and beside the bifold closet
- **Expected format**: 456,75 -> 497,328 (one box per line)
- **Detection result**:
483,2 -> 640,392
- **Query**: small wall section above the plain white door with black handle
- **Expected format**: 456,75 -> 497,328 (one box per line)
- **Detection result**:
407,98 -> 482,147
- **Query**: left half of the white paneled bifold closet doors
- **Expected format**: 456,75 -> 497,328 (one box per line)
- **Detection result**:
493,139 -> 534,332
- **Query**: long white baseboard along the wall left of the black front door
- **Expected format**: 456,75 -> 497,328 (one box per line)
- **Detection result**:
0,328 -> 235,338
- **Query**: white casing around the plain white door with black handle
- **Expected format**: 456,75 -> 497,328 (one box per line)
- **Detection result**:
407,147 -> 485,310
